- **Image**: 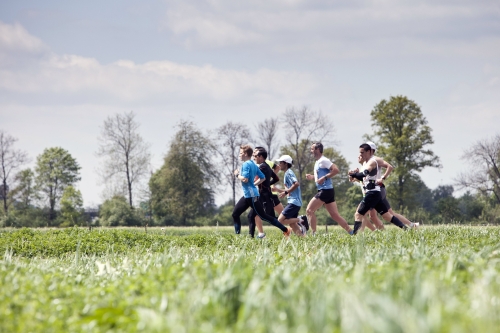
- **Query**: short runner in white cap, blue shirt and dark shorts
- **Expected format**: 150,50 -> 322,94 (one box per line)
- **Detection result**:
275,155 -> 309,236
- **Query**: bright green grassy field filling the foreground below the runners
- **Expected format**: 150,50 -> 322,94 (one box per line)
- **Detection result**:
0,226 -> 500,333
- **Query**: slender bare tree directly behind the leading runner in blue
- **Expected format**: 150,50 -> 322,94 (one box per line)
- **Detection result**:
216,121 -> 252,205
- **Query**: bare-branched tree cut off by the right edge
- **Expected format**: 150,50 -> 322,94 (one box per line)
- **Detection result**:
455,135 -> 500,204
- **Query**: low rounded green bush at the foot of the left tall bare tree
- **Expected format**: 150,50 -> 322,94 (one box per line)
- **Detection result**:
99,195 -> 143,227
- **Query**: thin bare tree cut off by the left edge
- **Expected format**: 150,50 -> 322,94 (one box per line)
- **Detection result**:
0,130 -> 29,214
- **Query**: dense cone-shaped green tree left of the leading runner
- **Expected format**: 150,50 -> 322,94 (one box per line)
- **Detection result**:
149,121 -> 218,225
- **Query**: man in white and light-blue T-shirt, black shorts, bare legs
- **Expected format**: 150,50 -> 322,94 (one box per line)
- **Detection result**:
306,142 -> 353,235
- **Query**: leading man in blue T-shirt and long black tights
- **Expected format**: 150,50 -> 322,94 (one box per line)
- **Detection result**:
232,145 -> 291,237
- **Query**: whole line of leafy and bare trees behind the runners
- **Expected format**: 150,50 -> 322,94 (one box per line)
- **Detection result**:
0,96 -> 500,227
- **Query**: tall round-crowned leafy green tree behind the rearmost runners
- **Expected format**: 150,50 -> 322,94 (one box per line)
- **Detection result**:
365,96 -> 441,208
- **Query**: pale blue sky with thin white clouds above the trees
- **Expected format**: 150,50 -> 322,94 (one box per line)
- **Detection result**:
0,0 -> 500,206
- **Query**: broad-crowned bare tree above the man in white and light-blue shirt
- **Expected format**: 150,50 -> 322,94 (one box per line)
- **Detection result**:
283,106 -> 335,179
